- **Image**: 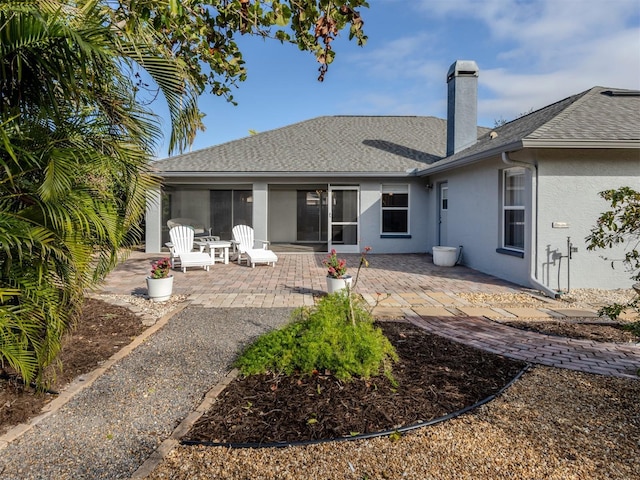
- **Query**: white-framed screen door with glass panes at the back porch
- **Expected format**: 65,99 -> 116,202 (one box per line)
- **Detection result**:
328,186 -> 360,253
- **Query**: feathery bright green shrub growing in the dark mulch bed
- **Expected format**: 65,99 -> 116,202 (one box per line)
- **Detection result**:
235,292 -> 398,380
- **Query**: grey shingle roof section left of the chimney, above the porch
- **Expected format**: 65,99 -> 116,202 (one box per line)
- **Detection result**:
155,116 -> 460,174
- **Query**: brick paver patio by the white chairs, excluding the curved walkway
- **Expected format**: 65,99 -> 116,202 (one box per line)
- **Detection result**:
102,252 -> 522,307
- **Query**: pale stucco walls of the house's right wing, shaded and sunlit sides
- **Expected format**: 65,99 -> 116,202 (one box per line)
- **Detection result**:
427,149 -> 640,291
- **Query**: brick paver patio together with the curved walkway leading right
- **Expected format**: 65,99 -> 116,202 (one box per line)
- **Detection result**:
101,252 -> 640,378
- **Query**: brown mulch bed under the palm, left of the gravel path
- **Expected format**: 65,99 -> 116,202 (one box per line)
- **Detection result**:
0,299 -> 146,435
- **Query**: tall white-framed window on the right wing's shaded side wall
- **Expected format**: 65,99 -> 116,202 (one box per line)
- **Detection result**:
502,168 -> 525,251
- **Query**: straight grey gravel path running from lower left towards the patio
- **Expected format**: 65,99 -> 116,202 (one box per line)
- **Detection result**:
0,307 -> 290,480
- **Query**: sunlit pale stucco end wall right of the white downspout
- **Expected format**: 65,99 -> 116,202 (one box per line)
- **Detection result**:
537,150 -> 640,291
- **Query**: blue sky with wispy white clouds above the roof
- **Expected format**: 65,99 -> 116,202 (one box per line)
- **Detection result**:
158,0 -> 640,158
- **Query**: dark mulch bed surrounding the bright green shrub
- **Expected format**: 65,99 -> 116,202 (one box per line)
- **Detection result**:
183,322 -> 524,443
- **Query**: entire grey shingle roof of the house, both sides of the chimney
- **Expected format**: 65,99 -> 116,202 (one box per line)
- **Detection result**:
154,87 -> 640,176
